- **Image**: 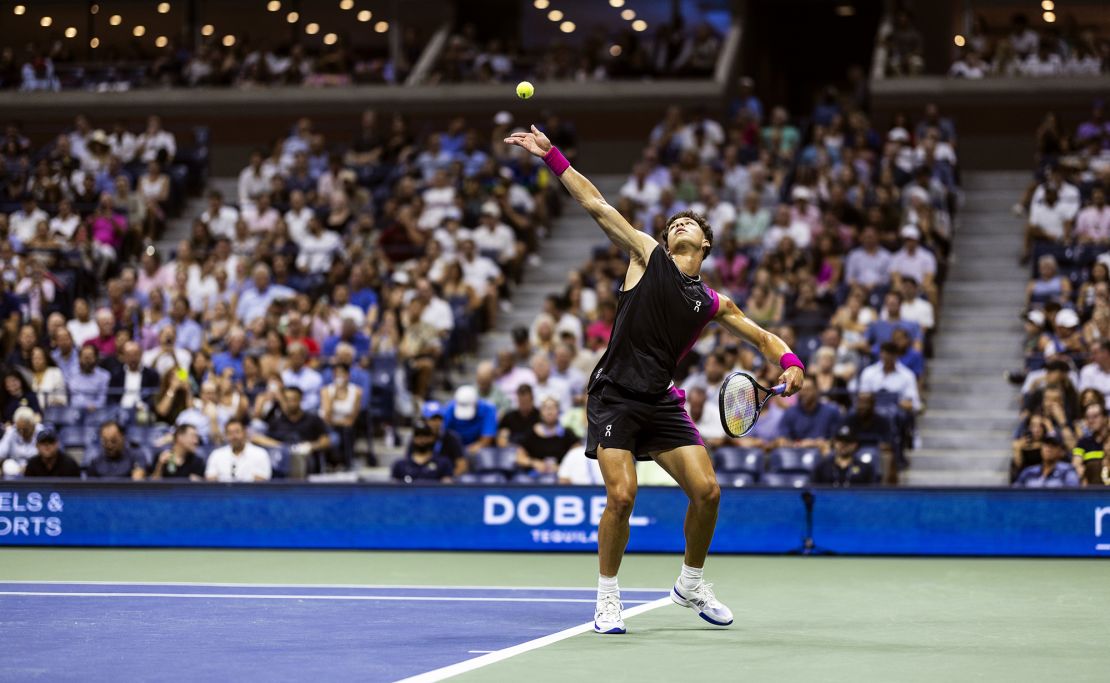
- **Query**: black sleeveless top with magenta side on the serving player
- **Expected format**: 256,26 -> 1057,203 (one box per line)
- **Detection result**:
589,245 -> 720,394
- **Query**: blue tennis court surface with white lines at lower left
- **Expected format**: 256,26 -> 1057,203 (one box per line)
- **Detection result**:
0,582 -> 666,681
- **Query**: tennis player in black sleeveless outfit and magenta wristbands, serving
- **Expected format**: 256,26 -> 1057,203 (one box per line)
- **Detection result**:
505,125 -> 805,633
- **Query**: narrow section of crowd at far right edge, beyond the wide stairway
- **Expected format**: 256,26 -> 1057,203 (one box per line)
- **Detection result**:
1010,102 -> 1110,486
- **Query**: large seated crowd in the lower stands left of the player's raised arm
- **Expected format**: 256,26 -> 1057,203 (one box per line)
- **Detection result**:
0,110 -> 558,481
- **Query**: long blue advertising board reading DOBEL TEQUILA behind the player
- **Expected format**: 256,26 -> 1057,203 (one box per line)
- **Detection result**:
0,481 -> 1110,556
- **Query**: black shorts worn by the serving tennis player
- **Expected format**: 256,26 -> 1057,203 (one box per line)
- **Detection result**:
586,381 -> 705,460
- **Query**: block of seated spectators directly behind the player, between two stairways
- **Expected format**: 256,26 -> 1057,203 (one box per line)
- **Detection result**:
395,94 -> 958,485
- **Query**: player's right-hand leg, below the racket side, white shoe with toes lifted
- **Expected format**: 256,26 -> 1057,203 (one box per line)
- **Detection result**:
652,444 -> 733,626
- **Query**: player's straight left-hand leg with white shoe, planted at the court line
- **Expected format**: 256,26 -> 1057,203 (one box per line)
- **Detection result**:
594,446 -> 636,633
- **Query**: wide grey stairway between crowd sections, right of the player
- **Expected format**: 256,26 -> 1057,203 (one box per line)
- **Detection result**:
902,171 -> 1029,486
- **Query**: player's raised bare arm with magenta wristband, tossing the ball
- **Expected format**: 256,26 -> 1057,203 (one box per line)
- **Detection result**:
505,125 -> 656,263
